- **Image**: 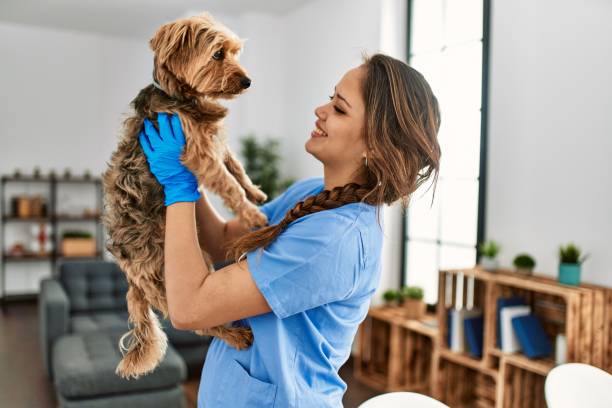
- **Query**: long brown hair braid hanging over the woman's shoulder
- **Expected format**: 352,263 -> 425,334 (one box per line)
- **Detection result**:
227,183 -> 371,261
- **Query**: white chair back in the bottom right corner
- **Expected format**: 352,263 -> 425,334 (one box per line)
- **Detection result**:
544,363 -> 612,408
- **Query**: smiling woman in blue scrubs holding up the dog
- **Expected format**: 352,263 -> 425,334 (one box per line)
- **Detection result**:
140,54 -> 440,408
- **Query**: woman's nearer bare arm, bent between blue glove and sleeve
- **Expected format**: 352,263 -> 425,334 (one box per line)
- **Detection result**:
164,202 -> 271,330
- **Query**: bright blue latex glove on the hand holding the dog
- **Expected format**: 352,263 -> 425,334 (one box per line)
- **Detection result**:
138,112 -> 201,206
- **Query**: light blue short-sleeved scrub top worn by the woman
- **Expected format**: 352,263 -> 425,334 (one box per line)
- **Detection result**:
198,177 -> 384,408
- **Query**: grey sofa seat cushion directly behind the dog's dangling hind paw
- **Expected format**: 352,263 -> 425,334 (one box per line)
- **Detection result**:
52,332 -> 187,398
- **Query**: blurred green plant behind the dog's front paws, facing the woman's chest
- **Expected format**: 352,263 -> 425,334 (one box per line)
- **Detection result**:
240,134 -> 295,202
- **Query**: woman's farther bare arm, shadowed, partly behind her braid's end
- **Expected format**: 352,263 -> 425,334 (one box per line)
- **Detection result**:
195,190 -> 249,263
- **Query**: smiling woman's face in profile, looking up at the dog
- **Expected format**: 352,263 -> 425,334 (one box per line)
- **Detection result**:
305,66 -> 365,175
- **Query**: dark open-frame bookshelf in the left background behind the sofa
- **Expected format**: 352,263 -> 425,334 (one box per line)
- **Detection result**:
0,175 -> 104,306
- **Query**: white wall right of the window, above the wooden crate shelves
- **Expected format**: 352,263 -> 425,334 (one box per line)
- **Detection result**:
486,0 -> 612,286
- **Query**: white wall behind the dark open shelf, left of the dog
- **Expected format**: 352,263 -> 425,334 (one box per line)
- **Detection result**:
0,23 -> 150,293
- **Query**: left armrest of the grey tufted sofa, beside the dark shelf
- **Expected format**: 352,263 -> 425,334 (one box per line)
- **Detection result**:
38,278 -> 70,378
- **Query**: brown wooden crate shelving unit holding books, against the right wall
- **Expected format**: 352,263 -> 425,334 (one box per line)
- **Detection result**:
355,266 -> 612,408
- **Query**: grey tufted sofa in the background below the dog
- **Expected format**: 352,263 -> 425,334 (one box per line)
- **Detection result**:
38,261 -> 216,408
